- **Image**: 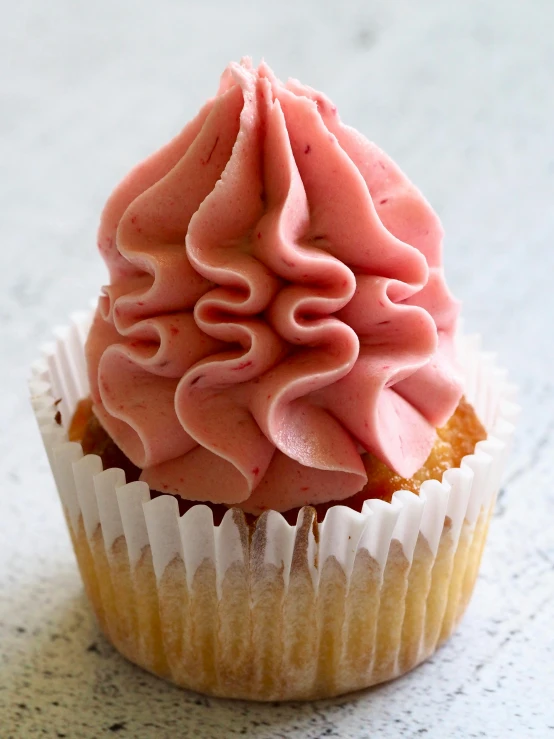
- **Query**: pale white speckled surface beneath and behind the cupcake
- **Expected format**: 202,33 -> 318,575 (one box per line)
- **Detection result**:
0,0 -> 554,739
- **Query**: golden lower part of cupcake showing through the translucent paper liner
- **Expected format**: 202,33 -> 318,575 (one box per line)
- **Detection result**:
72,498 -> 489,701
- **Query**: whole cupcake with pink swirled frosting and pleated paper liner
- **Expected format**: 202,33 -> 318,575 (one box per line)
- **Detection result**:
32,60 -> 516,700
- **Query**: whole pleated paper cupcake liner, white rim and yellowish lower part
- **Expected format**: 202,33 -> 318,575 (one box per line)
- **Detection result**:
30,314 -> 518,700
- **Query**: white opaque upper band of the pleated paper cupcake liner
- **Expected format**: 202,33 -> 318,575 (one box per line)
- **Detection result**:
30,314 -> 519,697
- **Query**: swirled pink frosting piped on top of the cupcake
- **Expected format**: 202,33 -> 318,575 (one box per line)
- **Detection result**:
87,60 -> 461,513
